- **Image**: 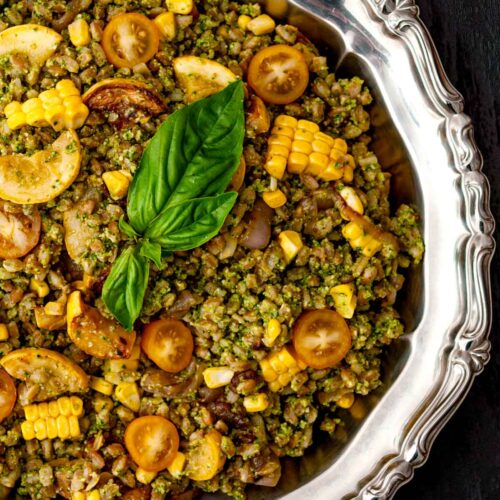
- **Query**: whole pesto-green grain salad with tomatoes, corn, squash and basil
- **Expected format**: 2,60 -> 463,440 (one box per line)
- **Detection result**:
0,0 -> 424,500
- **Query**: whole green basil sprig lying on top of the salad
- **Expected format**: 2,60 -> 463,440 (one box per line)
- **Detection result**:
102,81 -> 245,330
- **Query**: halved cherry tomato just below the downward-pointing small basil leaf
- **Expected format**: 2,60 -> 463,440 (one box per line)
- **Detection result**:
141,319 -> 194,373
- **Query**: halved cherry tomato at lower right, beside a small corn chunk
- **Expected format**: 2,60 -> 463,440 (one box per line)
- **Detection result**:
293,309 -> 352,370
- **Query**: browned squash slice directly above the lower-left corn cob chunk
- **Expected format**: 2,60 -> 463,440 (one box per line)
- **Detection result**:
0,347 -> 89,401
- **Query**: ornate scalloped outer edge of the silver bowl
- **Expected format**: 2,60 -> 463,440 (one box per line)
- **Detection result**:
352,0 -> 495,500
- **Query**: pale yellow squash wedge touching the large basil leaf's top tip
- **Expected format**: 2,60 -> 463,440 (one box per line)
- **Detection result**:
173,56 -> 236,103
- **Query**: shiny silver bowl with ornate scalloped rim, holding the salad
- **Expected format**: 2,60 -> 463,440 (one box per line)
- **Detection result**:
243,0 -> 495,500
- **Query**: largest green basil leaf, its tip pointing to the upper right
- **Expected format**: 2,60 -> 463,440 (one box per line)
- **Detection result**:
127,81 -> 245,234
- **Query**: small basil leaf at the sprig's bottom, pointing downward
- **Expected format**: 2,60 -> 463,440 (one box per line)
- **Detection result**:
102,247 -> 149,331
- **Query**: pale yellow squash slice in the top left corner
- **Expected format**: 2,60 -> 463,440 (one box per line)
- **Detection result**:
0,24 -> 62,66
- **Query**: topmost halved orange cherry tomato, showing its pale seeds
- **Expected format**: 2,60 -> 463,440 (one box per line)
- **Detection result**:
102,12 -> 160,68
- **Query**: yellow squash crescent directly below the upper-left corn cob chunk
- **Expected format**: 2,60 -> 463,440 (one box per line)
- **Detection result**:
0,130 -> 81,204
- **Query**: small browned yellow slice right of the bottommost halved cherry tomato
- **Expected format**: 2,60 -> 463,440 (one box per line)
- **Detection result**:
186,430 -> 226,481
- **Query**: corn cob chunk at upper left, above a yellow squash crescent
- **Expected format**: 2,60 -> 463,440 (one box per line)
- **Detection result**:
4,80 -> 89,131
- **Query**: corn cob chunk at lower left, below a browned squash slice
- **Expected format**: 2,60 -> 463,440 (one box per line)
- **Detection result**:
21,396 -> 83,441
